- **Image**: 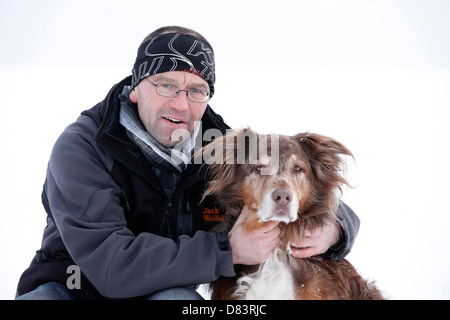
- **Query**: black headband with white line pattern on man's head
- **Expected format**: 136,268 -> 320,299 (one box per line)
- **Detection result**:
131,33 -> 216,96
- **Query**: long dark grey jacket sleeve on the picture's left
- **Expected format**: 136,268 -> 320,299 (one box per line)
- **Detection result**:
44,116 -> 234,298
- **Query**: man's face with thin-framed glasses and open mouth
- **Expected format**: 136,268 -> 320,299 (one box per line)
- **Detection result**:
130,71 -> 209,147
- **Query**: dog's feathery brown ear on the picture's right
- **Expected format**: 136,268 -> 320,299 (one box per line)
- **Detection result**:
293,133 -> 354,191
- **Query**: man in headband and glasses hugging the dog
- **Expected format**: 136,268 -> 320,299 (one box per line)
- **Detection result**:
17,27 -> 359,299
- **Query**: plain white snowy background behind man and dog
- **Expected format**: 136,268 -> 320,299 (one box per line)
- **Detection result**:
0,0 -> 450,299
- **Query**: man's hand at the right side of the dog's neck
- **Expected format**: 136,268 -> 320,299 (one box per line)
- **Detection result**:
291,222 -> 340,258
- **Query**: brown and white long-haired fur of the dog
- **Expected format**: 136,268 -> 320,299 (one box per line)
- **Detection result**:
202,129 -> 383,300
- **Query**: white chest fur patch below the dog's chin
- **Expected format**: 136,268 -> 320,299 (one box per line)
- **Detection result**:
233,249 -> 294,300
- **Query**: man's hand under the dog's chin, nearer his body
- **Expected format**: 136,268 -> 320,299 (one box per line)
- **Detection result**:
228,206 -> 281,265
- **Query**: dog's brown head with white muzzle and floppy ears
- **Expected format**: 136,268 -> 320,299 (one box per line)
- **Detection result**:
203,129 -> 352,237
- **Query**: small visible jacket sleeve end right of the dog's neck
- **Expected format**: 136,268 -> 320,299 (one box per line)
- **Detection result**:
323,200 -> 360,260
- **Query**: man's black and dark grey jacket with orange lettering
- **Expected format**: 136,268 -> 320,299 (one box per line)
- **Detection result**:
17,77 -> 359,299
